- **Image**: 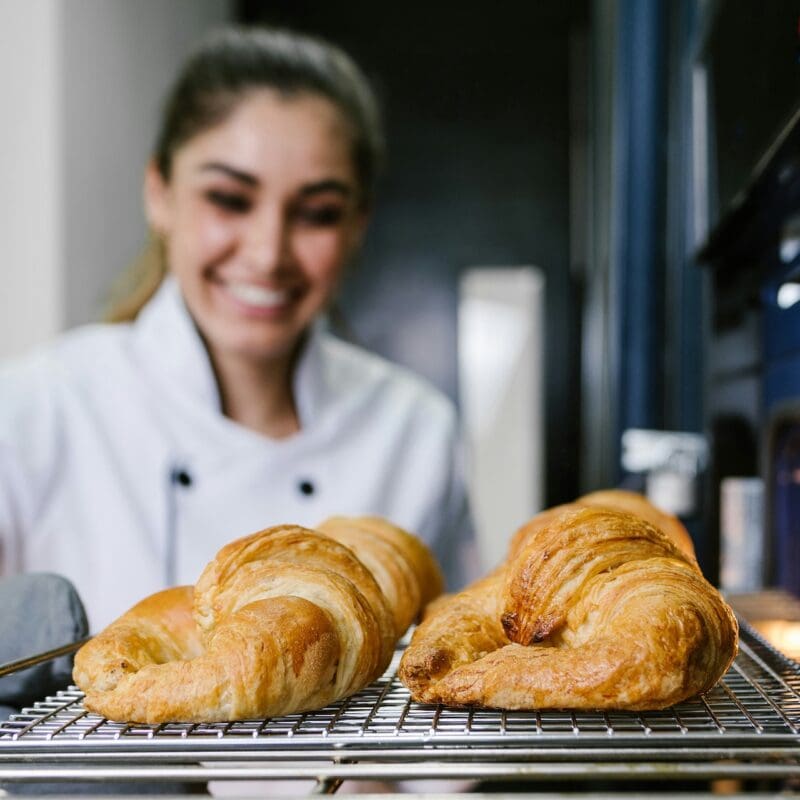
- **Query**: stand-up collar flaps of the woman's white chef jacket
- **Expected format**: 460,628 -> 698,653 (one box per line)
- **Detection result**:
134,275 -> 326,428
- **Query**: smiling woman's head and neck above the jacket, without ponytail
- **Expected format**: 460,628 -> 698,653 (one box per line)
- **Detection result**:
122,30 -> 382,437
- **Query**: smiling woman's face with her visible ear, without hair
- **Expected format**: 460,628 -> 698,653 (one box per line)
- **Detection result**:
145,91 -> 365,361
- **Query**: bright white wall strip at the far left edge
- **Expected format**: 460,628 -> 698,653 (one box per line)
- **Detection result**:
0,0 -> 63,356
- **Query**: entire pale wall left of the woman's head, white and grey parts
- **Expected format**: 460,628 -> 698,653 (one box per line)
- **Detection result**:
0,0 -> 230,357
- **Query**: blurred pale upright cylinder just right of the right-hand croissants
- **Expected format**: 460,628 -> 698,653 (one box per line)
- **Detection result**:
719,478 -> 765,594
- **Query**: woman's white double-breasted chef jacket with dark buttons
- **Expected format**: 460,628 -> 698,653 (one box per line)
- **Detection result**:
0,278 -> 477,631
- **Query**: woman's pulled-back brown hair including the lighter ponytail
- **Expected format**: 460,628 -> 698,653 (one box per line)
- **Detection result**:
107,26 -> 384,322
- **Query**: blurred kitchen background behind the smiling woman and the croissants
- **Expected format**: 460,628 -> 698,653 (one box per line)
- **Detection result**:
0,0 -> 800,592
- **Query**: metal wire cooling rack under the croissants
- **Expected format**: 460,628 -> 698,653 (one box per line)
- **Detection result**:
0,626 -> 800,786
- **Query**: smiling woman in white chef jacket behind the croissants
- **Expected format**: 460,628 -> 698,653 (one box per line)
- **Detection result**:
0,29 -> 474,629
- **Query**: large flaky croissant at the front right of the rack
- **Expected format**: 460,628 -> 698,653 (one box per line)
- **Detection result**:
399,493 -> 738,710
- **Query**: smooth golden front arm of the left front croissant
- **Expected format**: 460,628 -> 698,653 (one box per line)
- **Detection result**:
76,596 -> 340,723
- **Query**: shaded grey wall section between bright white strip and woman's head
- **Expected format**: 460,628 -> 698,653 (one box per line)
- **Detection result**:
60,0 -> 229,325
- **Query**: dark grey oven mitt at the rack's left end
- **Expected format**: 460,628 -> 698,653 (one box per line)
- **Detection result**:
0,573 -> 89,719
